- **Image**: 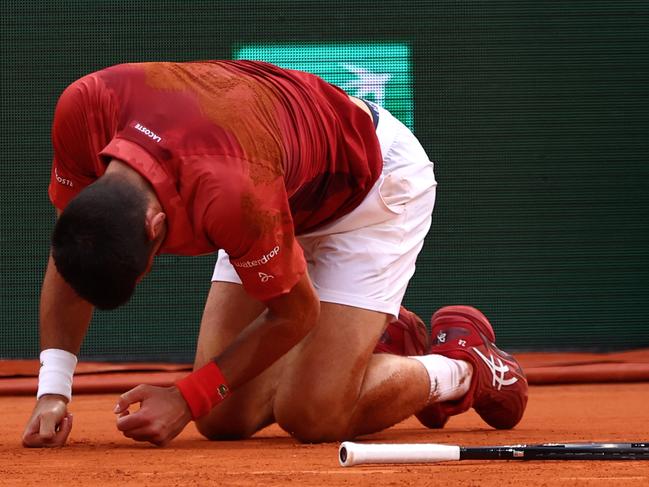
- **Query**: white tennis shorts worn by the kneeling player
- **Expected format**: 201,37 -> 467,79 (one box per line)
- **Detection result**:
212,107 -> 437,318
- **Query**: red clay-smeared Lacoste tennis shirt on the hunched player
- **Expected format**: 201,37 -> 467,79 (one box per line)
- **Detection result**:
49,61 -> 382,300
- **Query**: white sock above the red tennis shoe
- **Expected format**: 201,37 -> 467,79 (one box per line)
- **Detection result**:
408,354 -> 473,404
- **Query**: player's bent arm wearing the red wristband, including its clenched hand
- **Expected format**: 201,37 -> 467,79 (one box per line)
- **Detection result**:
114,274 -> 320,445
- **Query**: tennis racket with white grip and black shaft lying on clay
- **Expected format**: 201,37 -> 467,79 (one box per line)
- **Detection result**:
338,441 -> 649,467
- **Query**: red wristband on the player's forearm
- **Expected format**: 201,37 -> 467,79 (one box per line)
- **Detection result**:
176,361 -> 230,419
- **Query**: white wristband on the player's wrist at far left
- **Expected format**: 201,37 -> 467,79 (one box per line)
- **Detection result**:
36,348 -> 77,401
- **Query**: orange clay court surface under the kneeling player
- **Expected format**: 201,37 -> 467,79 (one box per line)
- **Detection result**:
0,383 -> 649,487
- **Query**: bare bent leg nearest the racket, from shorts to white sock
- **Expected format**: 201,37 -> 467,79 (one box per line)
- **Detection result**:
274,303 -> 430,442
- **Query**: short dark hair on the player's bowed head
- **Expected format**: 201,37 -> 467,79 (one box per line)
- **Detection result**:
52,175 -> 153,309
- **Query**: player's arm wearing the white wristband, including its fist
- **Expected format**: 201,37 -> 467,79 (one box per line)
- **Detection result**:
23,208 -> 93,447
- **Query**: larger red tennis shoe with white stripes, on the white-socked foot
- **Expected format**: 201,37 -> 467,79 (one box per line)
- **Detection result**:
416,306 -> 528,429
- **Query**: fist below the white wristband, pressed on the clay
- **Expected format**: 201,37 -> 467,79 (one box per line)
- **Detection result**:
23,394 -> 72,448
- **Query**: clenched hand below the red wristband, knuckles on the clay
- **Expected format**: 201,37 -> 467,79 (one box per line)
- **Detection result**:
114,385 -> 192,446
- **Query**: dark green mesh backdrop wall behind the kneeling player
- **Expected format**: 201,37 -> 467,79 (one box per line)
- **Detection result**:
0,0 -> 649,360
